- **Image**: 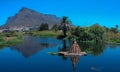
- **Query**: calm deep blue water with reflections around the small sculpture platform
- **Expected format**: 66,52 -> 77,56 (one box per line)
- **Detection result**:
0,36 -> 120,72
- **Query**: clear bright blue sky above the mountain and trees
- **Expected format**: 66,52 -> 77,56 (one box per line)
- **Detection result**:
0,0 -> 120,27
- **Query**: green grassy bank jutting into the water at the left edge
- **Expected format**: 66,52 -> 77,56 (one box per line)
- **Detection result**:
0,32 -> 23,48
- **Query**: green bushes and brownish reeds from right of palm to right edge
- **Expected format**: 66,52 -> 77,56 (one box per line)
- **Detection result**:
70,24 -> 120,43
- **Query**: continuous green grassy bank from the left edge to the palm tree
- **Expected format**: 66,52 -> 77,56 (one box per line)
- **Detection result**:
0,30 -> 62,48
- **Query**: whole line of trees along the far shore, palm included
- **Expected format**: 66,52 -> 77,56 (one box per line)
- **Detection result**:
30,17 -> 120,43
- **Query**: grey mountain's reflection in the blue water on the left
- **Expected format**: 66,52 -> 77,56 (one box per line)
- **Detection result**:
11,36 -> 57,58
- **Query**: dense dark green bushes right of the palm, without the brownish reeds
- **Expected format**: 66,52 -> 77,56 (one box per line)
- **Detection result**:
71,24 -> 105,42
